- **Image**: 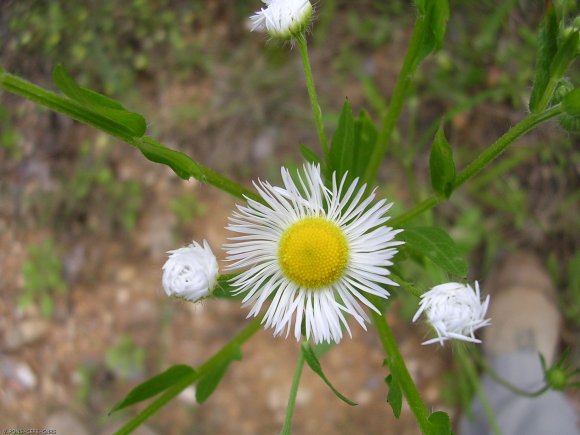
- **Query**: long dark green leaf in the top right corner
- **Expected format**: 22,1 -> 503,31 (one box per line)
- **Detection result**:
530,7 -> 558,113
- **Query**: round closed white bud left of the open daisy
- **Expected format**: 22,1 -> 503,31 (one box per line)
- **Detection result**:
163,240 -> 218,302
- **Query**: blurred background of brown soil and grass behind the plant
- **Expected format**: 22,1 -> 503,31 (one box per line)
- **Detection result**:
0,0 -> 580,435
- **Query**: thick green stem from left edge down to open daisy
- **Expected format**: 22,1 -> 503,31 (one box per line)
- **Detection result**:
0,69 -> 262,201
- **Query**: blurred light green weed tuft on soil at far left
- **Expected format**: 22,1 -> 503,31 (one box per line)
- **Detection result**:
18,238 -> 66,317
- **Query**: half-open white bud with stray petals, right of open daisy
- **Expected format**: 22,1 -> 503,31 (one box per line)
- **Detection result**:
413,281 -> 490,346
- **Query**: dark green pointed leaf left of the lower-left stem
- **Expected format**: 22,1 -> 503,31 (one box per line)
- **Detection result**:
109,365 -> 195,415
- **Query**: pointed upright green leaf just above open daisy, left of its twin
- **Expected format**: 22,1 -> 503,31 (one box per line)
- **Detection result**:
329,100 -> 354,180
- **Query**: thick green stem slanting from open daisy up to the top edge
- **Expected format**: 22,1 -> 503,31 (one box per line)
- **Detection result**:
365,15 -> 426,186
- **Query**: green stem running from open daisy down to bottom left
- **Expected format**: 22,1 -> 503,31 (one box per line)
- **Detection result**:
115,317 -> 262,435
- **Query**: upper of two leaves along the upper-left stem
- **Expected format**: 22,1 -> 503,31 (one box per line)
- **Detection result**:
52,65 -> 147,137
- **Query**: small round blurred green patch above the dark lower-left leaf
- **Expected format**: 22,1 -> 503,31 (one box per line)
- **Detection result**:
105,335 -> 145,379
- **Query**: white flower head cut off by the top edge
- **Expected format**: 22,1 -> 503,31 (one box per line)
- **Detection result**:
250,0 -> 312,39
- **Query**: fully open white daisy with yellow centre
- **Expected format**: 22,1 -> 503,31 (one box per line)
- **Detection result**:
225,165 -> 403,343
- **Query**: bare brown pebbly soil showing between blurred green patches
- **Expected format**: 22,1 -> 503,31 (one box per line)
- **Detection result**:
0,1 -> 578,435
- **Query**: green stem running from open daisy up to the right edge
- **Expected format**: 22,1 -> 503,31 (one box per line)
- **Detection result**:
389,104 -> 562,227
